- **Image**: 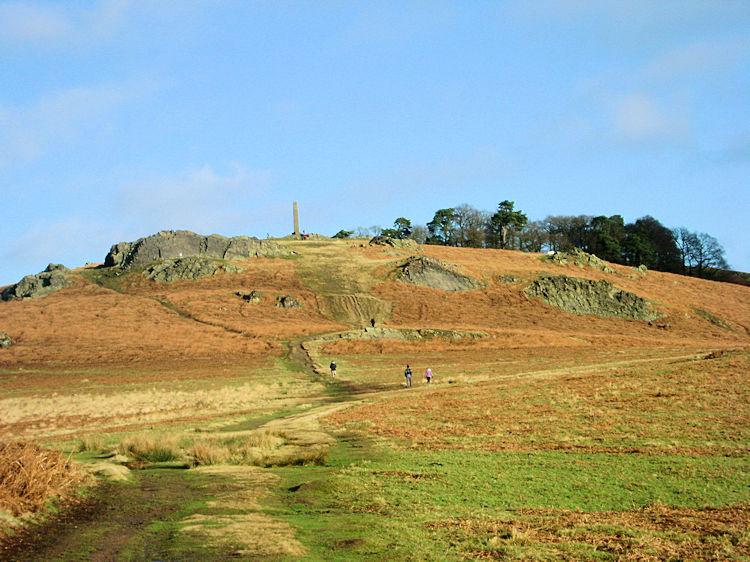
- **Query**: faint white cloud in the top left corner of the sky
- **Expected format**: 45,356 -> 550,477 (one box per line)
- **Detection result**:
0,0 -> 130,46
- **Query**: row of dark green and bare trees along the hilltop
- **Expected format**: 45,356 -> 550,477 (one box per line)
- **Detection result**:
334,200 -> 748,284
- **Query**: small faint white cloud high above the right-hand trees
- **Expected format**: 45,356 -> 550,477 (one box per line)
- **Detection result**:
613,93 -> 690,142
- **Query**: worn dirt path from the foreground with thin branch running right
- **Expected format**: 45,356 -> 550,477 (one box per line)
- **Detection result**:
0,340 -> 716,561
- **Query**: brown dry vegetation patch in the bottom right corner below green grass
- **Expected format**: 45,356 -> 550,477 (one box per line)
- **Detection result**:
430,503 -> 750,560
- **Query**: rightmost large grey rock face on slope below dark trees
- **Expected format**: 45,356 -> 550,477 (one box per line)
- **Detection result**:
526,275 -> 661,321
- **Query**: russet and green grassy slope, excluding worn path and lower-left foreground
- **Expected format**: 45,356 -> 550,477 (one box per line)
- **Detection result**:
0,241 -> 750,560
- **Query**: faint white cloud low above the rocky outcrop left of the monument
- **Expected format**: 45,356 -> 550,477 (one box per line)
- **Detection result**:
119,164 -> 278,234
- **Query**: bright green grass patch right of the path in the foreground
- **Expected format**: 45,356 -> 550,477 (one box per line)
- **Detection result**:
271,428 -> 750,560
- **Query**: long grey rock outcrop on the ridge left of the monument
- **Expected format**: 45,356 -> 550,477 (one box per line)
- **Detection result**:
104,230 -> 287,267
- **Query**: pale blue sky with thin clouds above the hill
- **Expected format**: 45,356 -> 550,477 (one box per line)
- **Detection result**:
0,0 -> 750,286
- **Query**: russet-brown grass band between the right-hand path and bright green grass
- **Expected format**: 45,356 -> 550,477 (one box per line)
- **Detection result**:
327,351 -> 750,456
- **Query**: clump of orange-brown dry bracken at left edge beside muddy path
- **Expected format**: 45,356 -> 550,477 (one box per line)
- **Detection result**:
0,442 -> 87,516
